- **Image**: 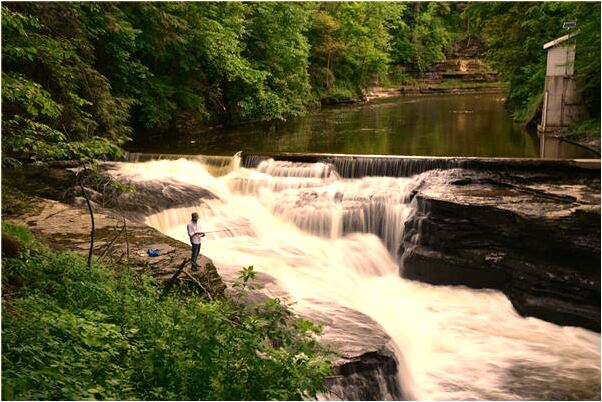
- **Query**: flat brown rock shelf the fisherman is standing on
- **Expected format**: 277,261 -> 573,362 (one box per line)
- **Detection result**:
4,197 -> 226,298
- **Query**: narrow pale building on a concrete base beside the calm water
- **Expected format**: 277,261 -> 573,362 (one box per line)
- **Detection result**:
539,31 -> 587,133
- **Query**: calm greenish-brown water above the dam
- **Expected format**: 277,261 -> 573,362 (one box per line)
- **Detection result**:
133,93 -> 599,158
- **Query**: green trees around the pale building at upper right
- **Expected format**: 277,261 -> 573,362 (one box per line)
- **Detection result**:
465,2 -> 600,121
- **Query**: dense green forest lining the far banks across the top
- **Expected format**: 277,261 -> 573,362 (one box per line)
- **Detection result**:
2,2 -> 600,163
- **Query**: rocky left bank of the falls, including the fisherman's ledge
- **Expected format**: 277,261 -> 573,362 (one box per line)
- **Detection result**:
2,166 -> 405,400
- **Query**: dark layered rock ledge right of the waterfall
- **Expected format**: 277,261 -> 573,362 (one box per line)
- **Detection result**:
400,171 -> 600,331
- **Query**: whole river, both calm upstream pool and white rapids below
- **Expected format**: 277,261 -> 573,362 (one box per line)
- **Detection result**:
114,94 -> 600,400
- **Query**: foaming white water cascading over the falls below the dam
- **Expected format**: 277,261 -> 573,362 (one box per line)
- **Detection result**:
105,160 -> 600,400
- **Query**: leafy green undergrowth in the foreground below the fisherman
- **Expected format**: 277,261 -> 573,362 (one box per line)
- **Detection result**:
2,225 -> 331,400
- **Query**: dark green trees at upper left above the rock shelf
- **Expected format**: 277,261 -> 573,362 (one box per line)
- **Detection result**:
2,3 -> 131,160
